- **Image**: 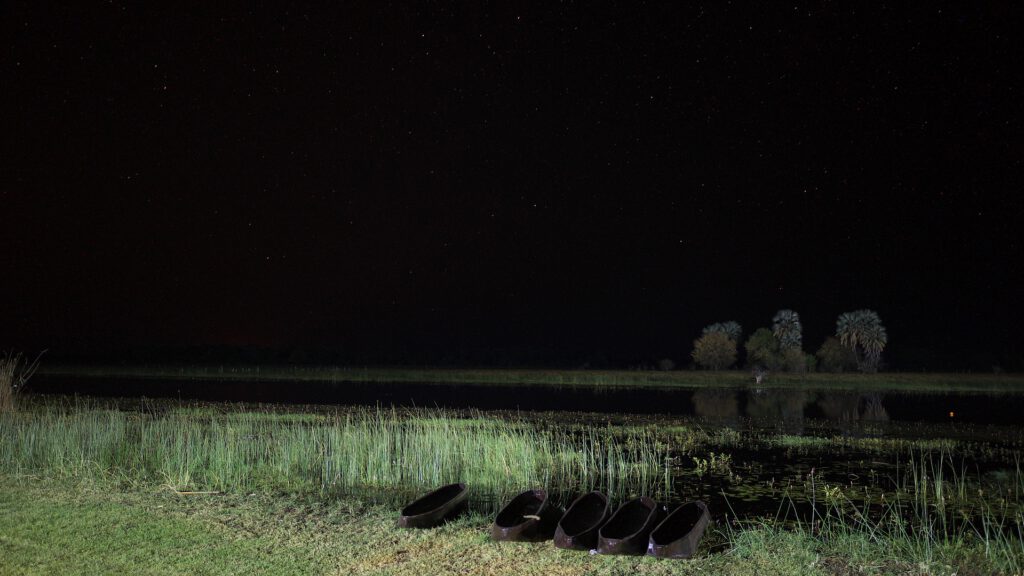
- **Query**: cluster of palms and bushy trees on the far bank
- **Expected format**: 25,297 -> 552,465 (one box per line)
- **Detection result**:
690,310 -> 889,372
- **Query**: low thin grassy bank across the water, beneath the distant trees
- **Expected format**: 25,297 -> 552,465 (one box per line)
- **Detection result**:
39,365 -> 1024,393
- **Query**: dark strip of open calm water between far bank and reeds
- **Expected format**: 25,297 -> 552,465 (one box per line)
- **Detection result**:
30,375 -> 1024,424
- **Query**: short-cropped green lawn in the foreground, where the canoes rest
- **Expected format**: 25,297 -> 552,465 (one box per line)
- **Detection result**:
0,477 -> 942,575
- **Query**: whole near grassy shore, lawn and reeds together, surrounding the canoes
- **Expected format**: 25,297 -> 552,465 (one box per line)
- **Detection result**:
0,399 -> 1024,574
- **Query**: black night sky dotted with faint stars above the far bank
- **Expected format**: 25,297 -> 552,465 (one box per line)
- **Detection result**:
0,2 -> 1024,370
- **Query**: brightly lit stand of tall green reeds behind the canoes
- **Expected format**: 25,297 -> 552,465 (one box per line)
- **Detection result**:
0,406 -> 668,511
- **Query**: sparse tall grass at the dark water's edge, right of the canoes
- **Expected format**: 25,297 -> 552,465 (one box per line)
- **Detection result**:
765,450 -> 1024,574
